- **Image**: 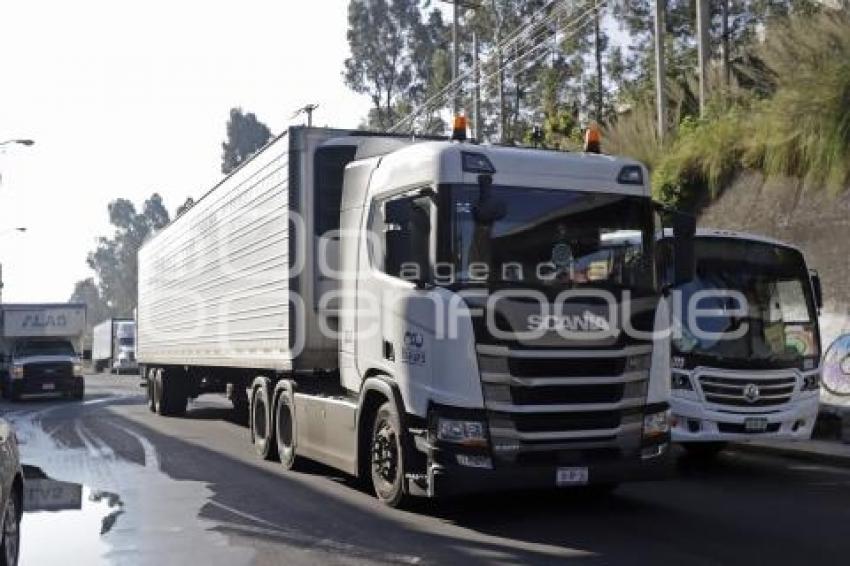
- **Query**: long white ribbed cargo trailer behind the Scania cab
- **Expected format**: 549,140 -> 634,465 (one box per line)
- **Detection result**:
137,127 -> 368,371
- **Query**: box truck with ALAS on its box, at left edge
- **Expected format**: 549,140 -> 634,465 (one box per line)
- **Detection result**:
0,303 -> 86,401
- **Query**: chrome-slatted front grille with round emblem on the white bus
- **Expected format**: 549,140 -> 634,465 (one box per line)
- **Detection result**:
699,375 -> 797,407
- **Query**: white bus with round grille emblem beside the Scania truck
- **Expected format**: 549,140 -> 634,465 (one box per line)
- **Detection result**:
662,229 -> 822,455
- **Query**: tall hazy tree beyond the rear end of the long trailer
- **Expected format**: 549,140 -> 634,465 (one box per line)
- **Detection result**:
87,193 -> 169,316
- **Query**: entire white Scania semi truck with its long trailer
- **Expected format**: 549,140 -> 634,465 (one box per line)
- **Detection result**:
137,127 -> 693,505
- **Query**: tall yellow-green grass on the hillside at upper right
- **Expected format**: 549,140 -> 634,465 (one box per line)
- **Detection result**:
609,12 -> 850,207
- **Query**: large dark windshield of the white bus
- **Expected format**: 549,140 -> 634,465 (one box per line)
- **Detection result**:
673,238 -> 820,367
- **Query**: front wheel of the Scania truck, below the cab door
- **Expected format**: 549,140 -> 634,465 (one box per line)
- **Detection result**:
369,401 -> 410,507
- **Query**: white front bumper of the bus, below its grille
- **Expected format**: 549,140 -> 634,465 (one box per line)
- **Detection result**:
670,393 -> 819,442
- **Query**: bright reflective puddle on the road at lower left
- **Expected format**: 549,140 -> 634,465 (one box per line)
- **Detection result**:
6,409 -> 255,566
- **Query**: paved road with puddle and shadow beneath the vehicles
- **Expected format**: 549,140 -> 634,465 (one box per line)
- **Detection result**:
0,375 -> 850,566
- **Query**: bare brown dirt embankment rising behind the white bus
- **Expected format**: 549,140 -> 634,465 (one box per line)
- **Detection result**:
699,172 -> 850,348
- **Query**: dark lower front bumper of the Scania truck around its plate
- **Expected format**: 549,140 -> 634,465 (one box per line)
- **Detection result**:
428,444 -> 674,497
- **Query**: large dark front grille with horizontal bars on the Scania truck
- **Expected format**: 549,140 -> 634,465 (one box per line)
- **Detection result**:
478,345 -> 651,464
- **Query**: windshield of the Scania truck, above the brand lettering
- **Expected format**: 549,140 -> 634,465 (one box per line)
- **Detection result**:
443,185 -> 655,292
